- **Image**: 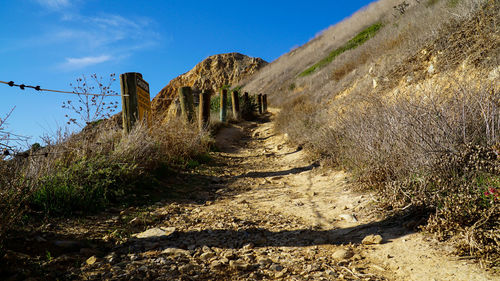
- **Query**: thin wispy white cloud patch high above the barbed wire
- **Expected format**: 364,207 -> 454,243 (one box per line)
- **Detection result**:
26,0 -> 161,70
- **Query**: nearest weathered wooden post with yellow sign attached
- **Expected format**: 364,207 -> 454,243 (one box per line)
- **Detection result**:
120,72 -> 151,134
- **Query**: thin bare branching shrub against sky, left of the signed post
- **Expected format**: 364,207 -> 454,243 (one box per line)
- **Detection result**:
62,73 -> 118,128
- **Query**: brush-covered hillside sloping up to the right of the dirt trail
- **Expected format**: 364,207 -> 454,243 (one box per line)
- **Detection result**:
242,0 -> 500,266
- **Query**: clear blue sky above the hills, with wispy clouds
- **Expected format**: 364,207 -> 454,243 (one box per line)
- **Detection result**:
0,0 -> 372,142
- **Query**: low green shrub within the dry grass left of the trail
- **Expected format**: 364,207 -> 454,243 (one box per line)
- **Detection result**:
30,157 -> 140,215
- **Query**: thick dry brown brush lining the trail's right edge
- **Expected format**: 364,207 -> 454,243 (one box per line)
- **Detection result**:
277,66 -> 500,263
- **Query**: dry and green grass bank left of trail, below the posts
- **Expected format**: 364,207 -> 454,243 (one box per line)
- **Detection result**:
0,115 -> 211,247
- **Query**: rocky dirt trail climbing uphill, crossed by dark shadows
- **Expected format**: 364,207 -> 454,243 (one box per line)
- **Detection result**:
0,110 -> 500,280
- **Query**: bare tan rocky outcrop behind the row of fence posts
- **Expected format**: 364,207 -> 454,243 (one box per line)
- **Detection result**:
152,53 -> 267,118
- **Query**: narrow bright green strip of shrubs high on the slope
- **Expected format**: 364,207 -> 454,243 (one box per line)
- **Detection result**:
299,23 -> 383,77
